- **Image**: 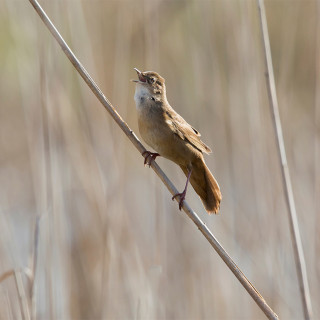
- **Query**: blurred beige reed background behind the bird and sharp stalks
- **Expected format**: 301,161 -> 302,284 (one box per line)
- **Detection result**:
0,0 -> 320,319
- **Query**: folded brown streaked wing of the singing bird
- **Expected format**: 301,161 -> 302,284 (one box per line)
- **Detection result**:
165,109 -> 211,153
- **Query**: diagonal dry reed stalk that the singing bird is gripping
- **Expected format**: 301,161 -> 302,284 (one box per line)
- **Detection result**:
29,0 -> 278,319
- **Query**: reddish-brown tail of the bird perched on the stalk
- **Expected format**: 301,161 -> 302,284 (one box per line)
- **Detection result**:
180,158 -> 222,214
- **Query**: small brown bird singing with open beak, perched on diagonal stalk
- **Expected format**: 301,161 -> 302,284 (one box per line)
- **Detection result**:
132,68 -> 221,214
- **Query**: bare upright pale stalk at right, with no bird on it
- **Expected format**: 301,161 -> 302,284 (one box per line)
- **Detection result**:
257,0 -> 312,320
